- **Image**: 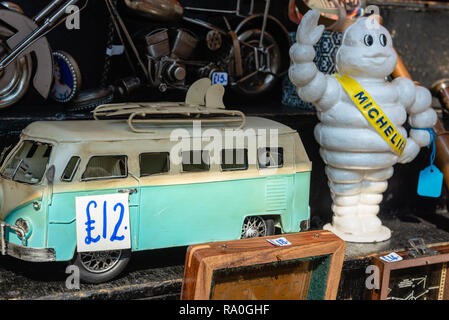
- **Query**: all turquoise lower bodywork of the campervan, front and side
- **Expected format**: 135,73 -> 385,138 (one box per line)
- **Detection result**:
6,172 -> 310,261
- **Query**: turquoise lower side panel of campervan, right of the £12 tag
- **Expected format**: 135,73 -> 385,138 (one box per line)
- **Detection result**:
138,173 -> 309,250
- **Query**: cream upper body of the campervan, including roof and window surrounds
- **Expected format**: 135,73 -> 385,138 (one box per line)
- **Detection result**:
14,117 -> 312,193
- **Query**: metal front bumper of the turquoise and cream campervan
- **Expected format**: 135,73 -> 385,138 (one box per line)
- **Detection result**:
0,221 -> 56,262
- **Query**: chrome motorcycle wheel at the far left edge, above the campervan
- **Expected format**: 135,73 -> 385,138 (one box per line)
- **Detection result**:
0,26 -> 32,109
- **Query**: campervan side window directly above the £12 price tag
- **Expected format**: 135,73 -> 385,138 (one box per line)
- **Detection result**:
81,156 -> 128,181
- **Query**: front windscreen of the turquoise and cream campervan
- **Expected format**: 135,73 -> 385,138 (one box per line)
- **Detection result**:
1,141 -> 52,184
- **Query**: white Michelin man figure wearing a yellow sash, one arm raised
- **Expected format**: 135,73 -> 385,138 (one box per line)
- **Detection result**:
289,10 -> 437,242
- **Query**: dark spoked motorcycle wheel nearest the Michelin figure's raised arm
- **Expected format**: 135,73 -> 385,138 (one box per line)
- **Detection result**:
229,29 -> 282,97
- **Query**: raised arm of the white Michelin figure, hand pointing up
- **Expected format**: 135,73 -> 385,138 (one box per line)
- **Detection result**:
289,10 -> 340,111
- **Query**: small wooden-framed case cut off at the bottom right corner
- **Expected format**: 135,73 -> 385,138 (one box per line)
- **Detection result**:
368,244 -> 449,300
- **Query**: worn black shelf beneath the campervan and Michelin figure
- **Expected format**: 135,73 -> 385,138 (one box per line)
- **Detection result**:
0,216 -> 440,300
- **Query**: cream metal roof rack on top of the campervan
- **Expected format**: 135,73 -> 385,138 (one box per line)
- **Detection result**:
92,102 -> 246,133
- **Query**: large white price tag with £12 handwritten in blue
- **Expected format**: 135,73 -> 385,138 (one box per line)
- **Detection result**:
75,193 -> 131,252
